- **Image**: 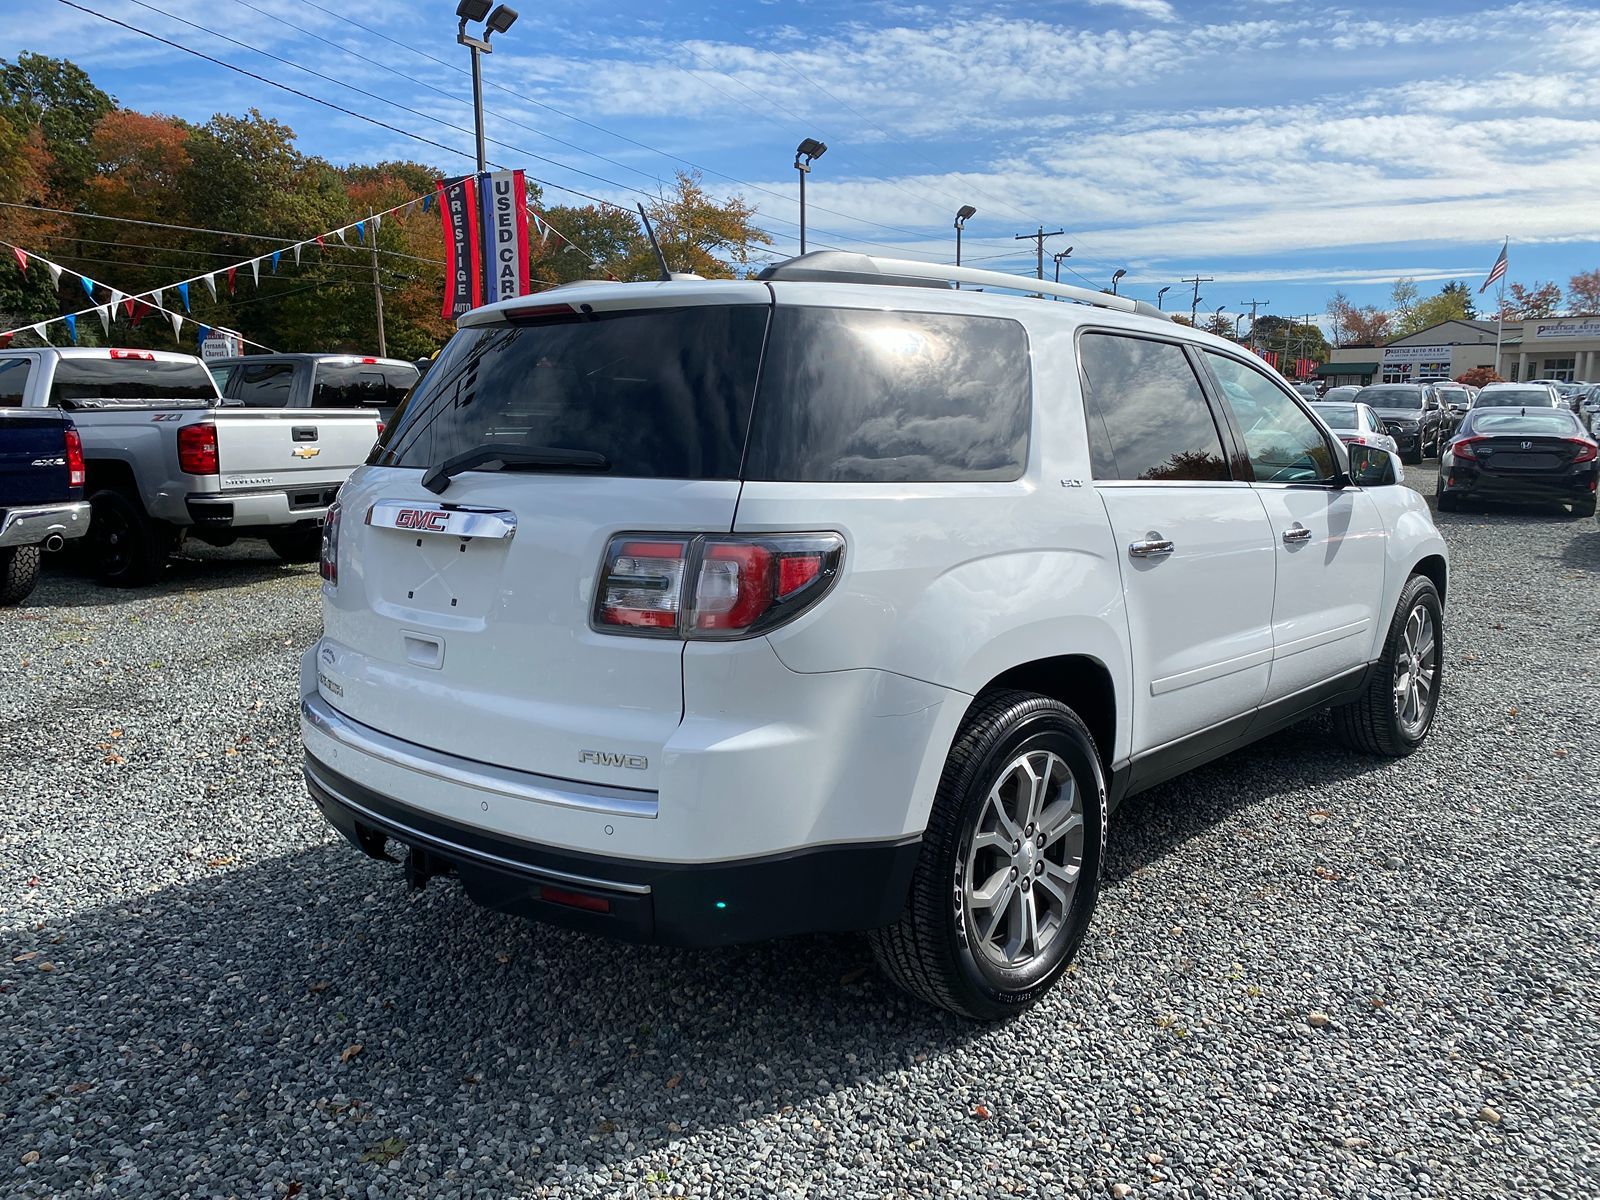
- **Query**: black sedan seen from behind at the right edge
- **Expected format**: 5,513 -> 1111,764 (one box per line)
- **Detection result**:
1435,408 -> 1600,517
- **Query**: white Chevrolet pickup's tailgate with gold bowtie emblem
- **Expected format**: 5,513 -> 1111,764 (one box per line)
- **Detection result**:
214,408 -> 378,494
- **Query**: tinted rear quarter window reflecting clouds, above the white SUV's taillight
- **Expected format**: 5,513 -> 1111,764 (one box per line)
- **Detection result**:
744,306 -> 1032,483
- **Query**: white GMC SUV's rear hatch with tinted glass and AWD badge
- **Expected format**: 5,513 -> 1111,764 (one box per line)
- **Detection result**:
318,282 -> 771,789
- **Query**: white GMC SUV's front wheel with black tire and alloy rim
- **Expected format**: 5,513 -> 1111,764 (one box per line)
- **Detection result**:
1333,574 -> 1445,758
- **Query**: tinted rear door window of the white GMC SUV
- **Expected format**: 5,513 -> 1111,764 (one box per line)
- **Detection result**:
1078,333 -> 1229,480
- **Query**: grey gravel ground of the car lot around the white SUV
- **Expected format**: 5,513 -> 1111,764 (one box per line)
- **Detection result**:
0,467 -> 1600,1198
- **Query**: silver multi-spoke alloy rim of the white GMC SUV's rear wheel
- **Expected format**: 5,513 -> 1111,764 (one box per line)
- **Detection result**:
960,750 -> 1085,970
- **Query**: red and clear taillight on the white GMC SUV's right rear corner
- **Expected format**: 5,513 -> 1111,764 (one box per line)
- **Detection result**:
594,533 -> 845,638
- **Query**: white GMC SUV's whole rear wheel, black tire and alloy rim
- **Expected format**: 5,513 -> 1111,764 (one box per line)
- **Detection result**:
869,691 -> 1106,1021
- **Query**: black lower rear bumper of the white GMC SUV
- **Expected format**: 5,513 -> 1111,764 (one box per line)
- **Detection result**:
306,752 -> 922,946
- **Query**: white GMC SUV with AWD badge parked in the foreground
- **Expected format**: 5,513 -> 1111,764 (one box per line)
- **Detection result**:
301,253 -> 1448,1018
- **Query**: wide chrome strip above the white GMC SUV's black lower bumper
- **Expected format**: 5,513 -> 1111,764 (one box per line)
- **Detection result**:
301,694 -> 659,819
